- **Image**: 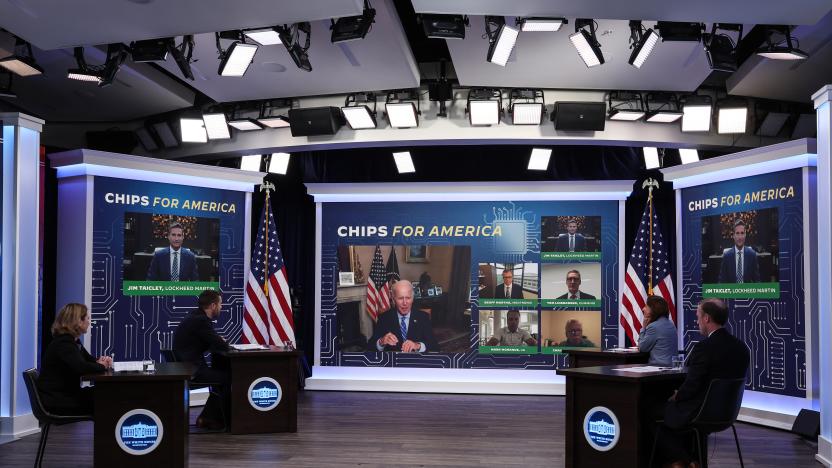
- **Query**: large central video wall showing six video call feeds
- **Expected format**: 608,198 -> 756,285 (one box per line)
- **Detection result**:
320,197 -> 619,369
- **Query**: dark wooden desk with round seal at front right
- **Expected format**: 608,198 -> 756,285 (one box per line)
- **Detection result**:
557,364 -> 686,468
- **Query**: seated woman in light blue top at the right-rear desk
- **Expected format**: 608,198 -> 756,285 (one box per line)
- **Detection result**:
638,296 -> 679,366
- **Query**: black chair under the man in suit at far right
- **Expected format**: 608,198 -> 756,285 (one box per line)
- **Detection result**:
650,378 -> 745,468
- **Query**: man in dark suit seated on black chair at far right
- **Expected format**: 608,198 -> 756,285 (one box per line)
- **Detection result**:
661,299 -> 750,467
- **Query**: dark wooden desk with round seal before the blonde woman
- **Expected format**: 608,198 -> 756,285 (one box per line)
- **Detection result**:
84,362 -> 196,468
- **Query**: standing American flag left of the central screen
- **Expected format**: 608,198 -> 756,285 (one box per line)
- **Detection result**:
243,191 -> 295,345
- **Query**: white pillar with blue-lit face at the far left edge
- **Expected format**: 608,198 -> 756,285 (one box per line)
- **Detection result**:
0,113 -> 44,443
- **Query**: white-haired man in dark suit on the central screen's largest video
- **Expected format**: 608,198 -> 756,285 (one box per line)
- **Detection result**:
367,280 -> 439,353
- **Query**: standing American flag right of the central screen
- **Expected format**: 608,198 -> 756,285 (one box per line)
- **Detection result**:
621,194 -> 676,344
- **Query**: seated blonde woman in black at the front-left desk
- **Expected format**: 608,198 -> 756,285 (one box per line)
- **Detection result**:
38,303 -> 113,415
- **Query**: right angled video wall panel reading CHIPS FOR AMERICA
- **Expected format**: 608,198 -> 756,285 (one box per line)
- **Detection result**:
678,169 -> 814,397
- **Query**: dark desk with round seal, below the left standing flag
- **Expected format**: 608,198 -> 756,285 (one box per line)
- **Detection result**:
225,350 -> 300,434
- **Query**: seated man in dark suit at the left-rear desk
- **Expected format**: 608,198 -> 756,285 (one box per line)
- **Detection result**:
173,289 -> 231,429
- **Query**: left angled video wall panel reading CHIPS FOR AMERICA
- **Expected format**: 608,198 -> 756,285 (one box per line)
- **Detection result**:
90,177 -> 246,360
